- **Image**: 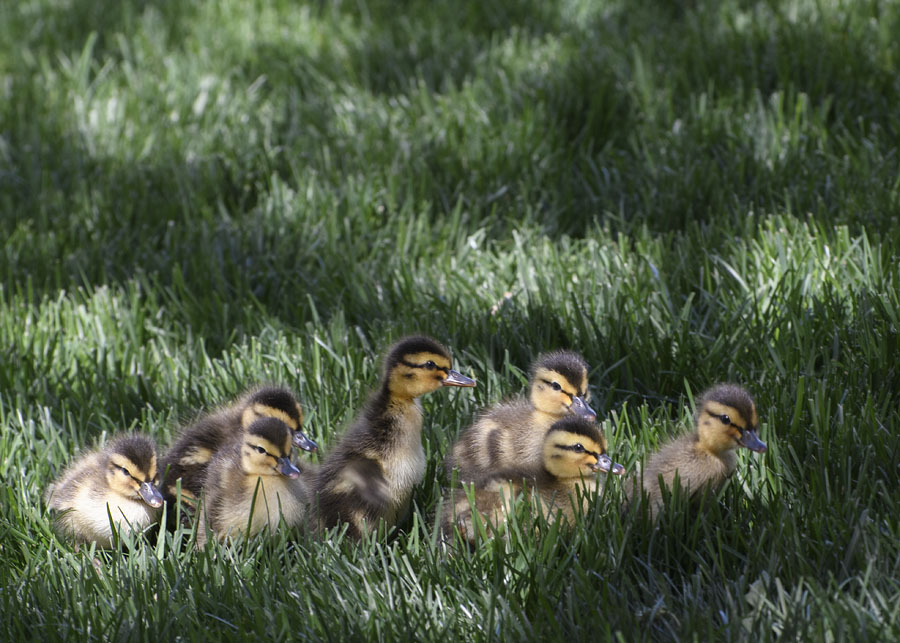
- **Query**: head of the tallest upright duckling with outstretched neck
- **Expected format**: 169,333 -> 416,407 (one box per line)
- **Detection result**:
383,336 -> 475,399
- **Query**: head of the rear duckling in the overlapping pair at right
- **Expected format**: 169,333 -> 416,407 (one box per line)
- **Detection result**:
531,351 -> 597,420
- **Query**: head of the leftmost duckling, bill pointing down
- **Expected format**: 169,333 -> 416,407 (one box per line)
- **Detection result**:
104,435 -> 163,508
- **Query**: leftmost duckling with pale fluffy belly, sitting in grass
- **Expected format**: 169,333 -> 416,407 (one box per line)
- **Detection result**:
45,435 -> 163,547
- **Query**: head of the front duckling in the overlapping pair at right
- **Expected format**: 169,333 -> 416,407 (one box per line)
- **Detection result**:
544,415 -> 625,478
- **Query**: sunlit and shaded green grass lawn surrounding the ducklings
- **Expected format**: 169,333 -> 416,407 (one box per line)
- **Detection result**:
0,0 -> 900,641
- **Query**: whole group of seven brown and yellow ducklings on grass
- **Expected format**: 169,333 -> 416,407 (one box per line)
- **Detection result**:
46,336 -> 766,546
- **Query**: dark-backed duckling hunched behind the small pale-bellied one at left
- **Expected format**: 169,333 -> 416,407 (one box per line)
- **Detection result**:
162,386 -> 317,503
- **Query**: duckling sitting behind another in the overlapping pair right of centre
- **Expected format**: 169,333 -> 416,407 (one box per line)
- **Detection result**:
446,351 -> 597,482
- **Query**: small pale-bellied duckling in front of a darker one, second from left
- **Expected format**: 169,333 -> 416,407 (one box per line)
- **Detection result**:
197,416 -> 310,547
